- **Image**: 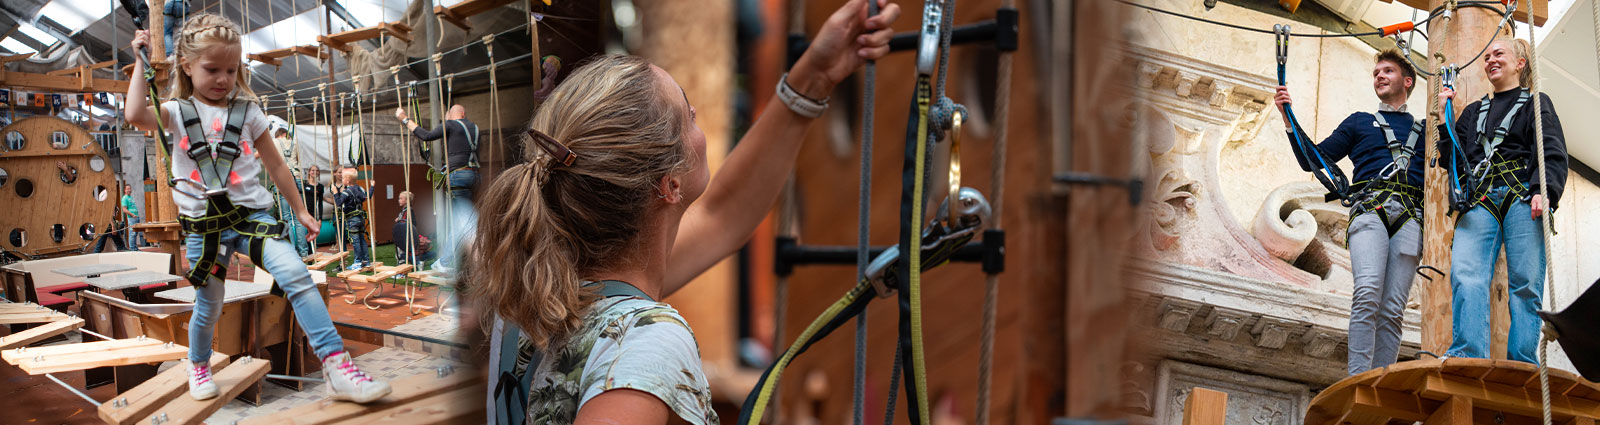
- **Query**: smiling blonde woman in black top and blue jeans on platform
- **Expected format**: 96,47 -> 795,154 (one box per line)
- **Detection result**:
1438,40 -> 1566,363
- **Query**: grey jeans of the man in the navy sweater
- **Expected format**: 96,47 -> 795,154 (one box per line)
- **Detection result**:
1347,201 -> 1422,375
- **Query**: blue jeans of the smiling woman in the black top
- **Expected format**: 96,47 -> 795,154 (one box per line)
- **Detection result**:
1448,187 -> 1549,364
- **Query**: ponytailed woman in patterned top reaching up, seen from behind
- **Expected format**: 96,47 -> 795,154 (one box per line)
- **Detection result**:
462,0 -> 899,423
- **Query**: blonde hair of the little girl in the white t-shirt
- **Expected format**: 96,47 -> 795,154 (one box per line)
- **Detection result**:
171,13 -> 256,101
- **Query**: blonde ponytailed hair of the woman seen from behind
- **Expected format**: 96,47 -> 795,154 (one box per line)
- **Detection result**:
459,56 -> 693,350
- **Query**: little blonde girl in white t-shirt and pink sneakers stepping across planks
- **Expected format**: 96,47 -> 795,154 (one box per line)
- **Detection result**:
125,14 -> 389,403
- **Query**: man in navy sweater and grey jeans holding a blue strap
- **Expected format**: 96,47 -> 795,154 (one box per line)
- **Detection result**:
1274,50 -> 1422,375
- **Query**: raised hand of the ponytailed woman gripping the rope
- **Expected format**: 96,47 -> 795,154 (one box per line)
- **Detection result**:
789,0 -> 901,99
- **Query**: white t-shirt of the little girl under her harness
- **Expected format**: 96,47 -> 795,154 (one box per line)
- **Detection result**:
162,97 -> 272,217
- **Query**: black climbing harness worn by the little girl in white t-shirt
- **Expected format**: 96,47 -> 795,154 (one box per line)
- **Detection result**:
178,99 -> 283,286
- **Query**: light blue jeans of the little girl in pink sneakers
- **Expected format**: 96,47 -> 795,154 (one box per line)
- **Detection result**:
184,211 -> 344,363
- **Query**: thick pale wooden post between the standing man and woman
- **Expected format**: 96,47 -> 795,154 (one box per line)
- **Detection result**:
1418,0 -> 1507,358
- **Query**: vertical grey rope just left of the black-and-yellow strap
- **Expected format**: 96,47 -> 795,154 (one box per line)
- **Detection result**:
850,0 -> 882,425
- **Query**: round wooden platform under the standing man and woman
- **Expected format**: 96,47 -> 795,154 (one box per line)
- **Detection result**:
1306,358 -> 1600,425
